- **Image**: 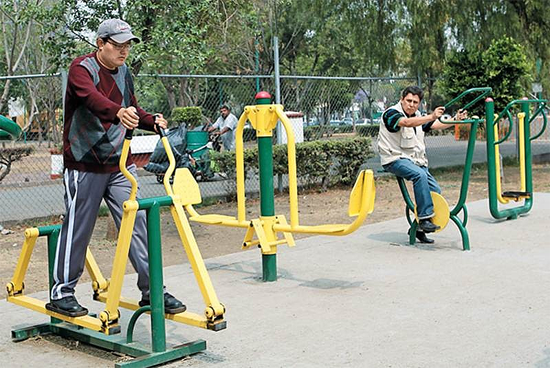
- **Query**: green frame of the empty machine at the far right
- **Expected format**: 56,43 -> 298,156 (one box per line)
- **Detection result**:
485,99 -> 548,219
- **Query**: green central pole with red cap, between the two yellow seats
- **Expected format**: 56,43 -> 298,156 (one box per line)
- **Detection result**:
256,92 -> 277,281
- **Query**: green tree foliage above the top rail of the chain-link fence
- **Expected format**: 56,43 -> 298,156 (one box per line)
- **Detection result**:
0,0 -> 550,108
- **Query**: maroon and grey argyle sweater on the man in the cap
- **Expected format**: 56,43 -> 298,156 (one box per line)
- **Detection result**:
63,52 -> 154,173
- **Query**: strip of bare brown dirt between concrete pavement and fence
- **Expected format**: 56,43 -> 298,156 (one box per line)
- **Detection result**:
0,164 -> 550,297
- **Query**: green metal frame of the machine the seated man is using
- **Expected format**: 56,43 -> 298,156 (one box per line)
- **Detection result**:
396,87 -> 491,251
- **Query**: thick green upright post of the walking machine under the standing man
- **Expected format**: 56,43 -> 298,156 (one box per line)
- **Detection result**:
147,202 -> 166,353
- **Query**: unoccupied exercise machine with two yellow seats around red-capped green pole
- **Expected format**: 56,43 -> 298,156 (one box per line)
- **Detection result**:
179,92 -> 375,281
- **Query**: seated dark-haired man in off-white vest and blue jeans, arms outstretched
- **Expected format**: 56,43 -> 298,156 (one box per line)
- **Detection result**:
378,86 -> 468,244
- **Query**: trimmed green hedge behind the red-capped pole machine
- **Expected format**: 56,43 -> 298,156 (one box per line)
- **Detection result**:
212,138 -> 374,188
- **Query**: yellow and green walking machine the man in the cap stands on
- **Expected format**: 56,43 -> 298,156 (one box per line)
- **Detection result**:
7,129 -> 226,367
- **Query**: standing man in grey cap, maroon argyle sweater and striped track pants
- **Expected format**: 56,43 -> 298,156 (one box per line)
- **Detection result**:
46,19 -> 186,317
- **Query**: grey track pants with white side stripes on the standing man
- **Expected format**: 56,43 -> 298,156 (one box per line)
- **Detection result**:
51,165 -> 149,300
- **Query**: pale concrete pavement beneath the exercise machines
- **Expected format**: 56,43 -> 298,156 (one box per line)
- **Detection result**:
0,193 -> 550,368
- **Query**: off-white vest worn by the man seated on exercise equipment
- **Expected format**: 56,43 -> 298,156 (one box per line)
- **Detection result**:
378,102 -> 428,166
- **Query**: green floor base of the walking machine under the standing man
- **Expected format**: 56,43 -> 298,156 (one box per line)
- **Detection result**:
11,322 -> 206,368
